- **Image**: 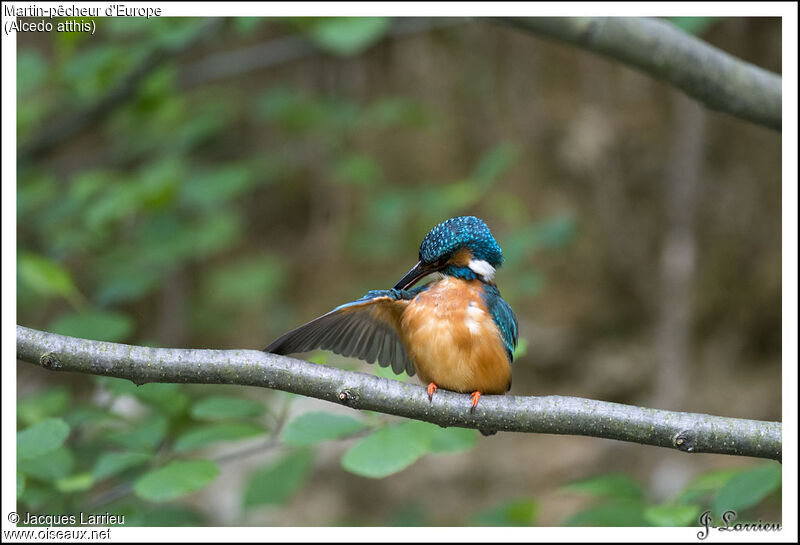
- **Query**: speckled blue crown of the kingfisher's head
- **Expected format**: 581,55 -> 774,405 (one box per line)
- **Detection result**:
419,216 -> 503,267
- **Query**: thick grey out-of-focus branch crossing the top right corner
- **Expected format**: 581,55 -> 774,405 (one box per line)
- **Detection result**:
493,17 -> 782,131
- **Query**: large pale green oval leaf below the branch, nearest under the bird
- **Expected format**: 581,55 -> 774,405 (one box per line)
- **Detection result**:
342,421 -> 432,478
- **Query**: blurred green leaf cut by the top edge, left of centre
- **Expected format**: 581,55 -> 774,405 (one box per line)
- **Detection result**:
309,17 -> 391,56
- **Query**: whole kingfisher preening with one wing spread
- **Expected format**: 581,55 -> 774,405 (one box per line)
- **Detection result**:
264,216 -> 518,416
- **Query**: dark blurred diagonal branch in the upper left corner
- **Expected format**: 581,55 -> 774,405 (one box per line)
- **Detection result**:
19,17 -> 224,163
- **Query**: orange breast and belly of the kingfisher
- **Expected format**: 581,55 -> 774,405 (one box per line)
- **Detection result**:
400,277 -> 511,394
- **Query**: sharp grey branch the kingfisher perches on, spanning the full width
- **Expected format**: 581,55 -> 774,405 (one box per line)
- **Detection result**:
17,326 -> 782,460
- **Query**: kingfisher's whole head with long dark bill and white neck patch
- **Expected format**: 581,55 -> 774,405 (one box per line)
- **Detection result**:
395,216 -> 503,289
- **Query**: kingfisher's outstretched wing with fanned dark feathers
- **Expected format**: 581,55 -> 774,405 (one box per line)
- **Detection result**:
264,286 -> 427,376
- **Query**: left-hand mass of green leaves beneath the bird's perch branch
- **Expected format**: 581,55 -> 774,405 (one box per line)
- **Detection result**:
17,378 -> 476,525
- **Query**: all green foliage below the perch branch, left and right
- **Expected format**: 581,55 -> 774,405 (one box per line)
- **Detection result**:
17,378 -> 781,526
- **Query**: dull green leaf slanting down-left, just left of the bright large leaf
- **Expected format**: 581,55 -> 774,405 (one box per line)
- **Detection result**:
244,449 -> 314,507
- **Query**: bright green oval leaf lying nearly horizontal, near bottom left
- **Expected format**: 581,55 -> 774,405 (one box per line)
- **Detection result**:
133,460 -> 219,502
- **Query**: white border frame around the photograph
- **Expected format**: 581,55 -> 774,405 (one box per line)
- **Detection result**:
0,2 -> 798,542
